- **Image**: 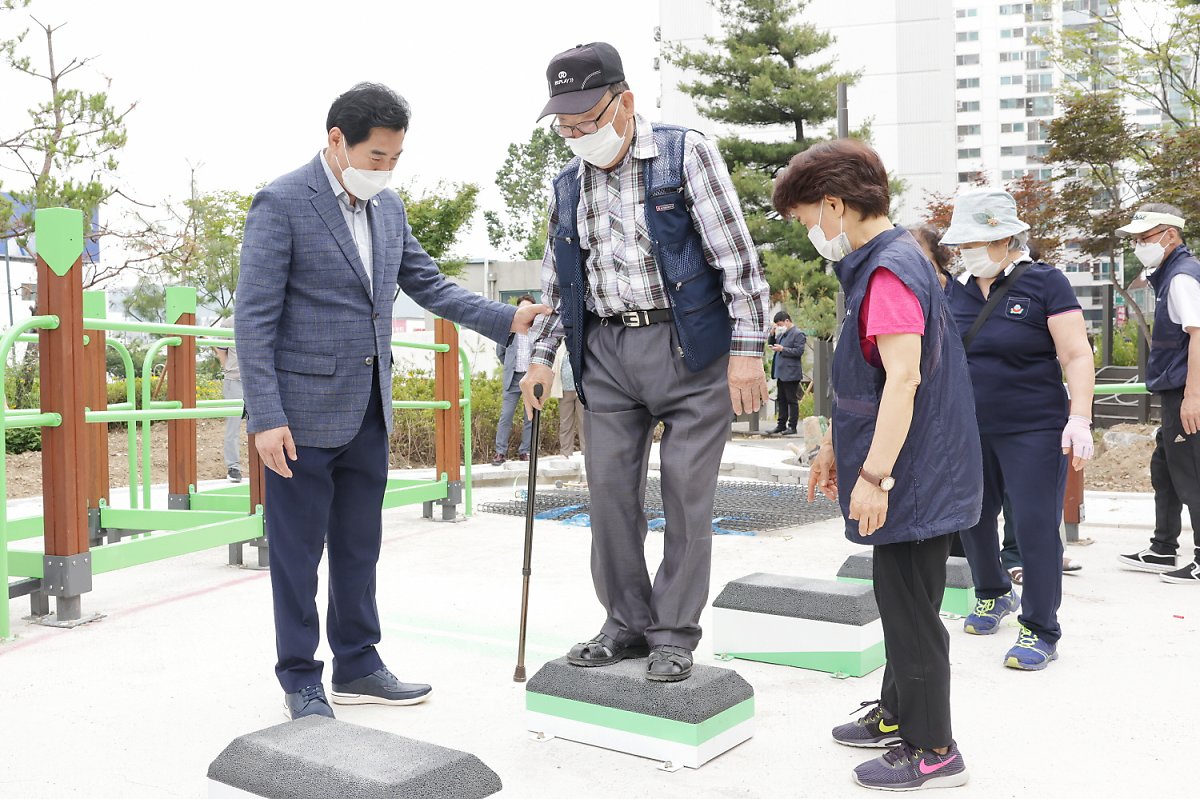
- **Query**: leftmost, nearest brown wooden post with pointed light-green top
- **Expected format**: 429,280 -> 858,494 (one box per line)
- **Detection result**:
34,208 -> 91,625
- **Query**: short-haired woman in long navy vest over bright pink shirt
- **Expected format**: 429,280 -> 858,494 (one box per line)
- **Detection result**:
774,139 -> 983,791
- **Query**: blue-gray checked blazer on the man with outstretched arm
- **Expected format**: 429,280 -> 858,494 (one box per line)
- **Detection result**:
234,154 -> 516,447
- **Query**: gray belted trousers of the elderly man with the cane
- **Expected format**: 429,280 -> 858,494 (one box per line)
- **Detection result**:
583,318 -> 733,650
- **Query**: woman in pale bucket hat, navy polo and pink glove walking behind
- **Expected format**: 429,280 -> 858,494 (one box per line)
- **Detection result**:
942,188 -> 1096,671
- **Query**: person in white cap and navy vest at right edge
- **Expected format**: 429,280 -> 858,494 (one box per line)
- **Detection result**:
1117,203 -> 1200,585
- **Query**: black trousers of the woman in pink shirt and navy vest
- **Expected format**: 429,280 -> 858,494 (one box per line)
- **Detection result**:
874,534 -> 953,749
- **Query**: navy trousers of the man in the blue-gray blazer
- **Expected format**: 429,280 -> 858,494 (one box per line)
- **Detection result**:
265,371 -> 388,693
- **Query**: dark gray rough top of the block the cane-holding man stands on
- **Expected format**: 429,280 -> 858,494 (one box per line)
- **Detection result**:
526,657 -> 754,725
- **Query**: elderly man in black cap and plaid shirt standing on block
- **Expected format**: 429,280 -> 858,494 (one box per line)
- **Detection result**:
521,42 -> 768,681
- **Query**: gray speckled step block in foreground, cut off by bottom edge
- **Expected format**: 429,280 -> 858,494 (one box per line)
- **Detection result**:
209,716 -> 502,799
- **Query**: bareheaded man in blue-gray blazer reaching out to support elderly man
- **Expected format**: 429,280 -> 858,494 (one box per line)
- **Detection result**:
235,84 -> 548,719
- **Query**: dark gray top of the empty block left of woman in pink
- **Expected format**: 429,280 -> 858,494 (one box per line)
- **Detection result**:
713,573 -> 880,626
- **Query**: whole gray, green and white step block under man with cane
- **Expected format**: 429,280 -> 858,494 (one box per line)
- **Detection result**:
526,657 -> 755,771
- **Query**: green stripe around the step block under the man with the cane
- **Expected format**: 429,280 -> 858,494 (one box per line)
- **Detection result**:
526,691 -> 754,746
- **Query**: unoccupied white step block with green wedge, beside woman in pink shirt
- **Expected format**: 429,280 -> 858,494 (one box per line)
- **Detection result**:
712,573 -> 884,677
